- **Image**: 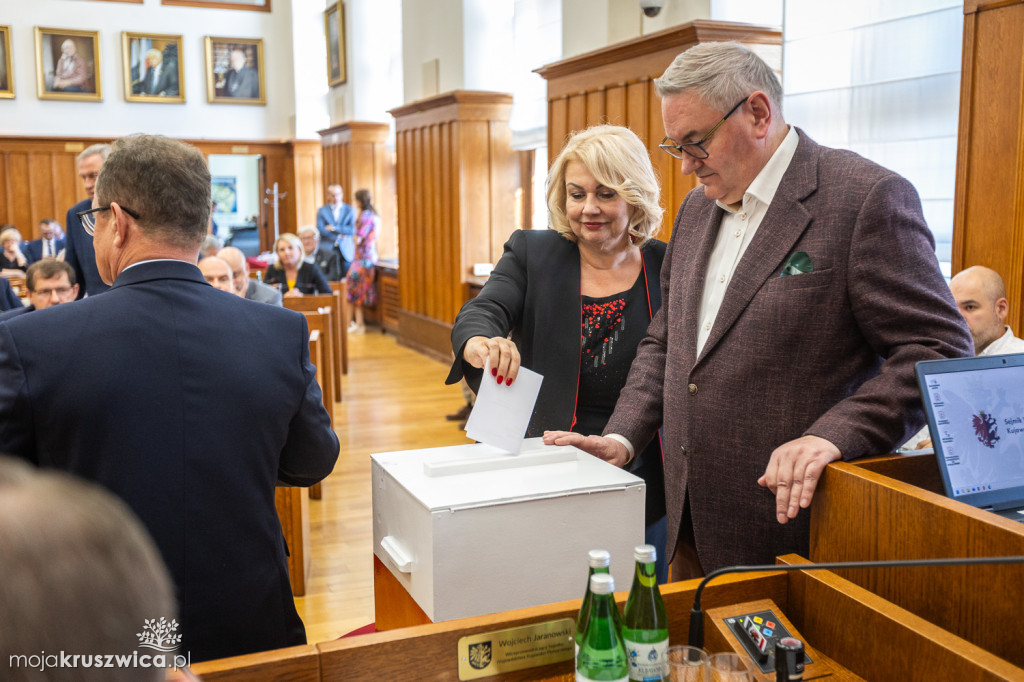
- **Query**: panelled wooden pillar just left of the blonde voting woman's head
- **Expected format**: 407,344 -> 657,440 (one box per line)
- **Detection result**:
390,90 -> 520,361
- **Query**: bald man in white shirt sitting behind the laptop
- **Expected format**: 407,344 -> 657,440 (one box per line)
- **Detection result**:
905,265 -> 1024,450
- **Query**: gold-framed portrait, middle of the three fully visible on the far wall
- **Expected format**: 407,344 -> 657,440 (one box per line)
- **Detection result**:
121,31 -> 185,104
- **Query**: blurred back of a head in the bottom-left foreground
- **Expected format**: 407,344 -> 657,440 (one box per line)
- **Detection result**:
0,457 -> 180,682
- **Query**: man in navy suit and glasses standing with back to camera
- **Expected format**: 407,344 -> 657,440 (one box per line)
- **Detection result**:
0,135 -> 338,662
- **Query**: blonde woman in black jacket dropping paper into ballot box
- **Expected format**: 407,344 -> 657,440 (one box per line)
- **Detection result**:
447,125 -> 666,579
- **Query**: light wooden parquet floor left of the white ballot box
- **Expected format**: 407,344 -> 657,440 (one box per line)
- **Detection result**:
295,329 -> 471,644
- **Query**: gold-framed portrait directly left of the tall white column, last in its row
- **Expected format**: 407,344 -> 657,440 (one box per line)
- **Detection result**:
206,36 -> 266,104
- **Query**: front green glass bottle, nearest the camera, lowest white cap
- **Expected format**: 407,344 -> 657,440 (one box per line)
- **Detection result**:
577,573 -> 630,682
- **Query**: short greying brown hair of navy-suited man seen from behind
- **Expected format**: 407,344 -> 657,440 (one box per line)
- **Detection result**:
96,135 -> 211,251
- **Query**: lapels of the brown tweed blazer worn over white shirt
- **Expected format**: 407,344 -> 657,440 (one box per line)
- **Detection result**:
689,128 -> 821,361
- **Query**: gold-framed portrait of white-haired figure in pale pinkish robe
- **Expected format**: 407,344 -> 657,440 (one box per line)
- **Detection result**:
35,26 -> 103,101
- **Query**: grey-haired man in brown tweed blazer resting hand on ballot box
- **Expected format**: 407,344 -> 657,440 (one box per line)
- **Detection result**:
546,43 -> 972,579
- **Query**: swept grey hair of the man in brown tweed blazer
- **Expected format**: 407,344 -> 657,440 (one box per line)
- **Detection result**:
654,42 -> 782,117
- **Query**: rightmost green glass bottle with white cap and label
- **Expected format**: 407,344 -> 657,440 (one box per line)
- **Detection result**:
623,545 -> 669,682
